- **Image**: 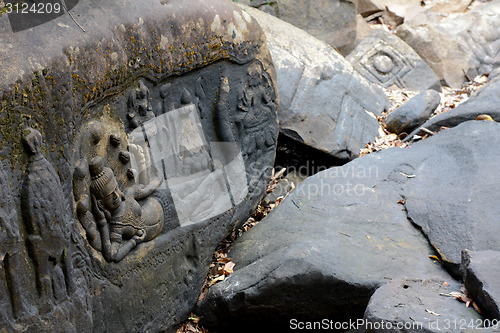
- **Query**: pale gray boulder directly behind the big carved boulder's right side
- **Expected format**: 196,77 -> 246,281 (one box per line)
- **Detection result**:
240,7 -> 388,159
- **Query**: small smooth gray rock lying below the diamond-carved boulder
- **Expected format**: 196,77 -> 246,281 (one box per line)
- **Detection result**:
385,90 -> 441,134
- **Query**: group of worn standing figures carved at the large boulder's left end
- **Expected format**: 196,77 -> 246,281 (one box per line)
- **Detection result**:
11,128 -> 91,329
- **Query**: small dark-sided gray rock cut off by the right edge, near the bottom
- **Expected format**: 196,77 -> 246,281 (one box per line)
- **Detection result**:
461,250 -> 500,320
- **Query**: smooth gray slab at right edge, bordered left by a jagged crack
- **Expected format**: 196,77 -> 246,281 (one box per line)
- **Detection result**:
404,121 -> 500,276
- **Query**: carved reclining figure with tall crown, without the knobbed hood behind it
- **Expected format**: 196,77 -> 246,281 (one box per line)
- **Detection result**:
89,157 -> 164,262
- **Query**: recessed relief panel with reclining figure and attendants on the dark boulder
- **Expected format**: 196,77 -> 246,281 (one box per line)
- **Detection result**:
73,62 -> 277,262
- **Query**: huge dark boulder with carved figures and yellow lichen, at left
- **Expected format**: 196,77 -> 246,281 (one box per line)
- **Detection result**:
0,0 -> 279,332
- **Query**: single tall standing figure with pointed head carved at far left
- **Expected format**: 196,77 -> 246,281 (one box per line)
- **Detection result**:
21,128 -> 74,311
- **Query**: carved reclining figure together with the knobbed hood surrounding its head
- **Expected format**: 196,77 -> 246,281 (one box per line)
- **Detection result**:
73,115 -> 168,262
